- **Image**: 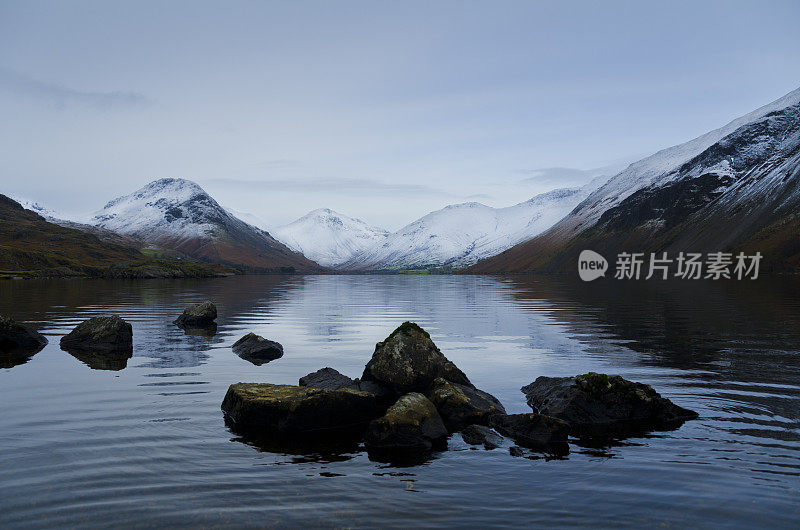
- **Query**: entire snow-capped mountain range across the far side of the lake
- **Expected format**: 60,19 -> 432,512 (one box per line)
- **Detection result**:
6,84 -> 800,273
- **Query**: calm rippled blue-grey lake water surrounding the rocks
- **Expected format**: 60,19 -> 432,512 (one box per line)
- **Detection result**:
0,276 -> 800,528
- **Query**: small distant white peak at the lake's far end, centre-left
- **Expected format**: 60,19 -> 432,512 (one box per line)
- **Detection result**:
271,208 -> 389,267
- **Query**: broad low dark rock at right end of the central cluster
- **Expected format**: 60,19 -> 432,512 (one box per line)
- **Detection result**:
522,372 -> 697,436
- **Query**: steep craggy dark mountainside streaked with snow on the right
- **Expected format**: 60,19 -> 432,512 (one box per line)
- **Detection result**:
472,85 -> 800,272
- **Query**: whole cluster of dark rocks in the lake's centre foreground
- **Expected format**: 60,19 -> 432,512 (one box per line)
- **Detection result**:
222,322 -> 697,460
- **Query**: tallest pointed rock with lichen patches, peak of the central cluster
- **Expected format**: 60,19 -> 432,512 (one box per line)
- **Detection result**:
361,322 -> 472,395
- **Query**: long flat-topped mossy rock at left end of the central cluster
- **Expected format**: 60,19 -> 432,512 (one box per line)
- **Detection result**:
222,383 -> 385,435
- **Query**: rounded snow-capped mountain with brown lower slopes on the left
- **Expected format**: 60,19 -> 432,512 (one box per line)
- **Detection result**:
91,178 -> 317,270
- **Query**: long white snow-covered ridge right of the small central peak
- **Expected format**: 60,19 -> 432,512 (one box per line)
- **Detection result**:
342,177 -> 602,270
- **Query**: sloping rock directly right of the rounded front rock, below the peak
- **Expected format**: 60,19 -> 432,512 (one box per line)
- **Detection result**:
427,377 -> 506,432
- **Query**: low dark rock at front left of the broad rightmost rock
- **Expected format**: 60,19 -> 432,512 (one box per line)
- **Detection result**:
489,414 -> 569,452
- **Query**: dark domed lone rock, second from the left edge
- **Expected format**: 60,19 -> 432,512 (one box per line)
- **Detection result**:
61,315 -> 133,357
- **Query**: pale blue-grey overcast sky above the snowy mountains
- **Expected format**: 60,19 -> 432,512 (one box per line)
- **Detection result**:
0,0 -> 800,230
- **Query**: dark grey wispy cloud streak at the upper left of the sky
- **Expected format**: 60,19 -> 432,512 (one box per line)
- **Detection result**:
0,67 -> 152,110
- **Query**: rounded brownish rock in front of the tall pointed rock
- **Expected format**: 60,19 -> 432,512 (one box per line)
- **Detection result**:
364,392 -> 447,458
